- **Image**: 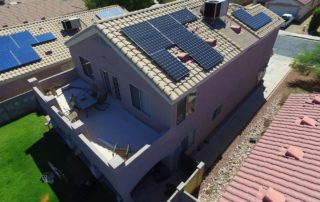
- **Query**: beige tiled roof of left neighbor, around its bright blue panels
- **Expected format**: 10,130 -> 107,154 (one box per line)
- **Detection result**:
0,6 -> 126,85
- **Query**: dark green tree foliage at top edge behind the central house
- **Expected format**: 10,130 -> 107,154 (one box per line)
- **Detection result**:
84,0 -> 153,11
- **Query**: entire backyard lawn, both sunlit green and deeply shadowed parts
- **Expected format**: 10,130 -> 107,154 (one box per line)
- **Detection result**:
0,113 -> 115,202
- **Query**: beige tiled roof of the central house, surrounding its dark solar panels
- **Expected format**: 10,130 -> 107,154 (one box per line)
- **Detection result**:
93,0 -> 282,101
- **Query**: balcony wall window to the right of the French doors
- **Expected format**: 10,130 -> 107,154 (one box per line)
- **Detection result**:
130,85 -> 150,115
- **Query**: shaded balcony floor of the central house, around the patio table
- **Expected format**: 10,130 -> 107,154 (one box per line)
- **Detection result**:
56,79 -> 161,159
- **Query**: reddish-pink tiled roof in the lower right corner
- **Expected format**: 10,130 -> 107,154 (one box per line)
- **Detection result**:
220,94 -> 320,202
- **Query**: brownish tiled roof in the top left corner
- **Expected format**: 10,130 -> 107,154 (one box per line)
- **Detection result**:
0,0 -> 86,27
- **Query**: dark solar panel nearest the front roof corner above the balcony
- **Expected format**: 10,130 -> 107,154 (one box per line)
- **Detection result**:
151,50 -> 189,81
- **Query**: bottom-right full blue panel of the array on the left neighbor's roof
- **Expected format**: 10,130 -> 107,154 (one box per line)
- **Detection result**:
13,47 -> 41,65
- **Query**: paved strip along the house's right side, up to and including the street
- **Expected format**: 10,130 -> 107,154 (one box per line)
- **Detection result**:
193,31 -> 319,168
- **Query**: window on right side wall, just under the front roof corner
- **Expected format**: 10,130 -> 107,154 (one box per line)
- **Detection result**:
177,92 -> 196,125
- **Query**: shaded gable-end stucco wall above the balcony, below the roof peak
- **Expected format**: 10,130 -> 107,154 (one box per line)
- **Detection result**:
70,36 -> 172,131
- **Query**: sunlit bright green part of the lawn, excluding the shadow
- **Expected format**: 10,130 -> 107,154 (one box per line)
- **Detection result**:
0,113 -> 58,202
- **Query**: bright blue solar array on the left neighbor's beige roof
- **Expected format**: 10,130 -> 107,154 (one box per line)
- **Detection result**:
0,31 -> 56,72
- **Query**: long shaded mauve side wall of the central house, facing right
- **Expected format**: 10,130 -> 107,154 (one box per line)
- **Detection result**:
172,27 -> 278,152
